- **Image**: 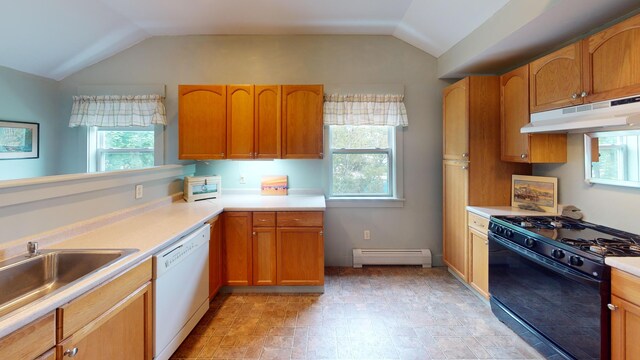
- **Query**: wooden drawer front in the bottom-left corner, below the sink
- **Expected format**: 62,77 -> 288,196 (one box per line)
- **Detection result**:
0,312 -> 56,359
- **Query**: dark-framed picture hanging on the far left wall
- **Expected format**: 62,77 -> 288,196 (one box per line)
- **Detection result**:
0,120 -> 40,160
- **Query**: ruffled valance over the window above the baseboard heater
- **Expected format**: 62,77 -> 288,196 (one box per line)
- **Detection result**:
324,94 -> 409,126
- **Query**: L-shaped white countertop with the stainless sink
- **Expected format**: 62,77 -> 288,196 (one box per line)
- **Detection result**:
0,195 -> 325,338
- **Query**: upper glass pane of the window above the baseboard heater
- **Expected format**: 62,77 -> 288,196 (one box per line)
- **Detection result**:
331,125 -> 393,149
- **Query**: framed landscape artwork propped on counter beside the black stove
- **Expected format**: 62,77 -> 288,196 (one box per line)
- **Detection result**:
511,175 -> 558,213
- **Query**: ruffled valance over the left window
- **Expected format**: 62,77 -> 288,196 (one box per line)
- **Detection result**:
69,95 -> 167,127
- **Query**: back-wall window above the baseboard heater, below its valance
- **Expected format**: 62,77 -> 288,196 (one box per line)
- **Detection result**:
329,125 -> 395,197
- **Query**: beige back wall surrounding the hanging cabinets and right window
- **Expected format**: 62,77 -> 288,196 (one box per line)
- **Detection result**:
61,36 -> 446,266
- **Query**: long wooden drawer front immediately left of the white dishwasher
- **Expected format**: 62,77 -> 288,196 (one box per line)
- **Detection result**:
57,258 -> 152,342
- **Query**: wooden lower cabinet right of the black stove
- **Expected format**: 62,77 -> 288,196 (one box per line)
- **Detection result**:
609,269 -> 640,360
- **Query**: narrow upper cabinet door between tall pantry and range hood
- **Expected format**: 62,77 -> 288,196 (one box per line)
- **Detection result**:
500,65 -> 529,162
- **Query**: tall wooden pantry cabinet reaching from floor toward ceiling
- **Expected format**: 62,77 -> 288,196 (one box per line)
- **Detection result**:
442,76 -> 531,281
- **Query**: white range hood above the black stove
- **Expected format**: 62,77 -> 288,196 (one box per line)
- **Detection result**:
520,95 -> 640,134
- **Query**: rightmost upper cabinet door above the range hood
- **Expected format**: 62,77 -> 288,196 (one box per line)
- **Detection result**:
582,15 -> 640,102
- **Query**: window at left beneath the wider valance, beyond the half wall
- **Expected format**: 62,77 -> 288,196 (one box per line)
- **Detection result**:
89,126 -> 163,171
